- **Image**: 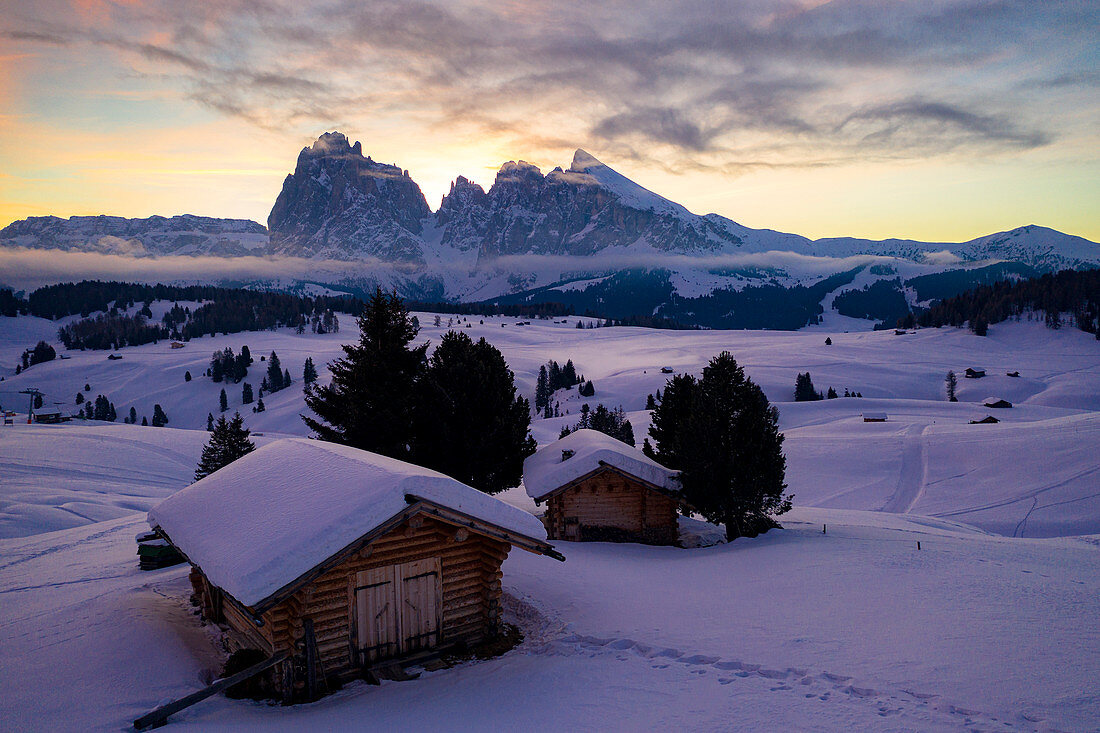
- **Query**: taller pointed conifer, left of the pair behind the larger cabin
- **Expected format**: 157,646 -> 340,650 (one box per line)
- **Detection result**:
303,288 -> 428,459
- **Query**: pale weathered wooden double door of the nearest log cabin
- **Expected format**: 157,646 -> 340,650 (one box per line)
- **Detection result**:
355,557 -> 443,664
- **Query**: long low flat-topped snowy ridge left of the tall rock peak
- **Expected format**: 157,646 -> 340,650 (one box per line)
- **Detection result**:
0,215 -> 267,258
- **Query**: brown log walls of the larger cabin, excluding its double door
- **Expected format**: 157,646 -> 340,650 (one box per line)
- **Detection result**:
240,510 -> 512,674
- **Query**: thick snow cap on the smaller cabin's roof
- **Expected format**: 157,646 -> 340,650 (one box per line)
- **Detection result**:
524,429 -> 680,500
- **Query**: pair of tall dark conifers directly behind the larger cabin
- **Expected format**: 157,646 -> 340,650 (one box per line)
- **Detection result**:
303,289 -> 535,493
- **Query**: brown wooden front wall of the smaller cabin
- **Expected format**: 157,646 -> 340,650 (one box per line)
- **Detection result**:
547,471 -> 678,544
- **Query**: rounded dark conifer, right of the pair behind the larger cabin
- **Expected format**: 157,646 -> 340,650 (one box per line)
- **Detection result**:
410,331 -> 536,494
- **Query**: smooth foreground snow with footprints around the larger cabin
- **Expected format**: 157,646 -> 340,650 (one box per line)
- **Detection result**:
0,510 -> 1100,731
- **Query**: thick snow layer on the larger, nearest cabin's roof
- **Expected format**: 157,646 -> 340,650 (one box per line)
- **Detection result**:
149,438 -> 547,606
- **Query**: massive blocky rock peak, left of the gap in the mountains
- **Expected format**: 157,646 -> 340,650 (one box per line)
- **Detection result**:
267,132 -> 431,262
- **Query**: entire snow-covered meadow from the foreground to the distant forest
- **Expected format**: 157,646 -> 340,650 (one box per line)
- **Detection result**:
0,303 -> 1100,731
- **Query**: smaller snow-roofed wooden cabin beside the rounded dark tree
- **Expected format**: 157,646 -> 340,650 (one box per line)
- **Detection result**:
524,429 -> 681,545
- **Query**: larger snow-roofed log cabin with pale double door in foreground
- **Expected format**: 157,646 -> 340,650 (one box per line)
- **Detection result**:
149,439 -> 564,697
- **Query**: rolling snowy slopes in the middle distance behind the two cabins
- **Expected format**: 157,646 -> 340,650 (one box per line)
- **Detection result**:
0,314 -> 1100,537
